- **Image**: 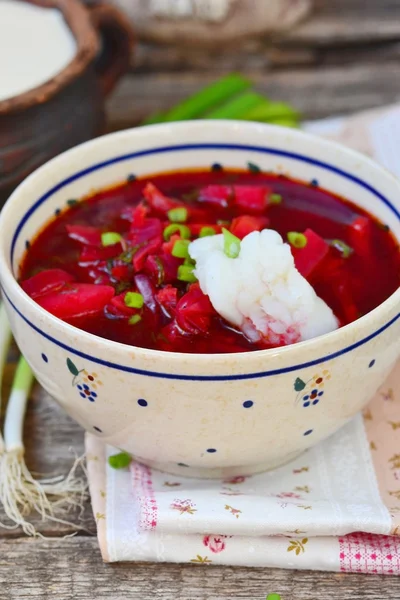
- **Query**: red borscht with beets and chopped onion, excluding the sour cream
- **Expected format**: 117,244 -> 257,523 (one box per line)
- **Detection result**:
20,168 -> 400,353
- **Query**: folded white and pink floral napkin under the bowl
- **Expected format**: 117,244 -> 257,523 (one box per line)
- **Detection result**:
86,107 -> 400,575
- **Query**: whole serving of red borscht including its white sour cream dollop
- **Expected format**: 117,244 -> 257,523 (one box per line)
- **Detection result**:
19,164 -> 400,353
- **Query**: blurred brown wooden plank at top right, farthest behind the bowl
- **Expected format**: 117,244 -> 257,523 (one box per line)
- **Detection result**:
133,0 -> 400,73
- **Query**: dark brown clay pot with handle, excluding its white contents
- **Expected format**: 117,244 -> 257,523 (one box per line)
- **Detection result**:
0,0 -> 133,205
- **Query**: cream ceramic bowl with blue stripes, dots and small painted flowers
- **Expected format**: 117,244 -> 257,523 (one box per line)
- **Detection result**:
0,121 -> 400,477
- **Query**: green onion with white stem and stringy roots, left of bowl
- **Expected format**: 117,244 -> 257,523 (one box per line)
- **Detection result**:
0,304 -> 87,536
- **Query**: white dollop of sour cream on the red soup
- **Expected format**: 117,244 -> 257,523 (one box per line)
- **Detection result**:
189,229 -> 339,345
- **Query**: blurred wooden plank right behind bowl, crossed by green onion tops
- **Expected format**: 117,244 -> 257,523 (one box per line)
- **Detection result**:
108,61 -> 400,129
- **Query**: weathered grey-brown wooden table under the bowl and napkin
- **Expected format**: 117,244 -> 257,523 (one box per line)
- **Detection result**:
0,0 -> 400,600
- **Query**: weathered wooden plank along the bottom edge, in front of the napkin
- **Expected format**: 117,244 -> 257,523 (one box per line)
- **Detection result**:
0,537 -> 400,600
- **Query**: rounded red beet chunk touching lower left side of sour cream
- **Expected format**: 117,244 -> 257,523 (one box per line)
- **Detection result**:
176,284 -> 216,335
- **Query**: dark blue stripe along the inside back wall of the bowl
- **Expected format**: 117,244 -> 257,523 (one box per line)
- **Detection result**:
10,143 -> 400,264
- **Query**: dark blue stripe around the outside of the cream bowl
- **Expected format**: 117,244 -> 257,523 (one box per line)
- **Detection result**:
2,289 -> 400,381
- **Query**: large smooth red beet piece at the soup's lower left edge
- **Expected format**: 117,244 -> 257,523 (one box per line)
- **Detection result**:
36,283 -> 114,320
